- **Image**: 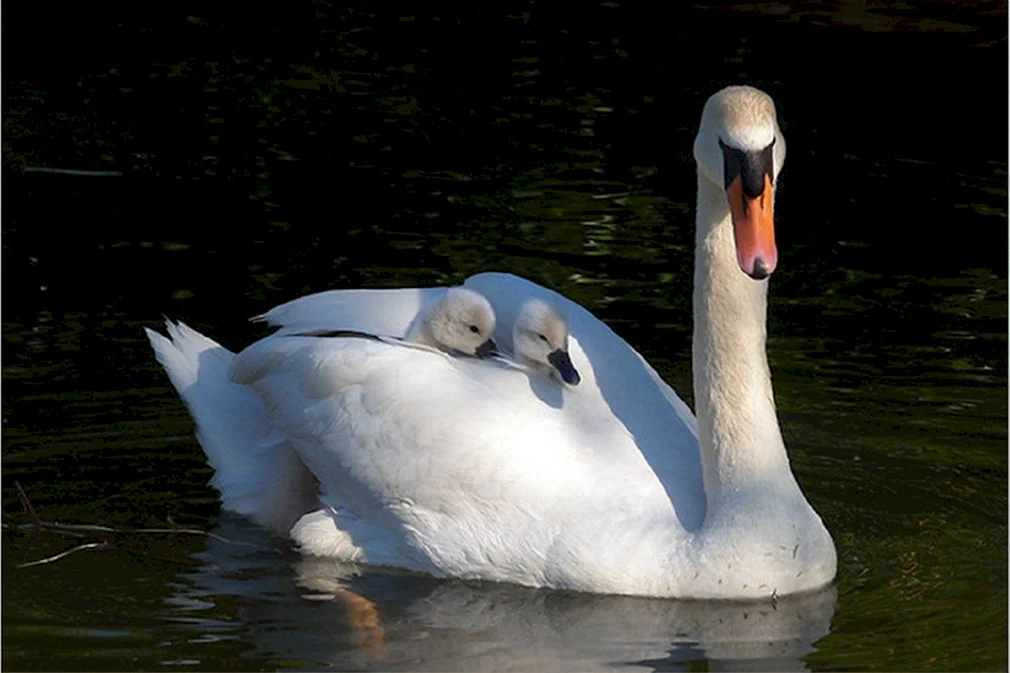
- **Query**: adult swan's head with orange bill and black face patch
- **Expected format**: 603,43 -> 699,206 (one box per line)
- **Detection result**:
694,86 -> 786,280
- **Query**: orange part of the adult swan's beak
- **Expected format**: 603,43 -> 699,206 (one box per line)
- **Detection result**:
726,175 -> 779,280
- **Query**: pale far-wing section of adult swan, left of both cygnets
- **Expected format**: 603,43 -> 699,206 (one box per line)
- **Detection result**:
254,287 -> 445,337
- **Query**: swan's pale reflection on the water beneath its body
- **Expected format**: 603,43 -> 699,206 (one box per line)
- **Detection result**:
172,516 -> 835,671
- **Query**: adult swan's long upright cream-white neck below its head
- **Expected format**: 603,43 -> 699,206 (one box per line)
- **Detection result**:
693,175 -> 795,514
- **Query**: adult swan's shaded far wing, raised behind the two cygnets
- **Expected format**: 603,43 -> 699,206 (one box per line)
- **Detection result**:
249,273 -> 706,531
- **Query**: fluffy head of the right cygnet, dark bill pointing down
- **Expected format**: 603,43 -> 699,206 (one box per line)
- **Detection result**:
512,298 -> 582,386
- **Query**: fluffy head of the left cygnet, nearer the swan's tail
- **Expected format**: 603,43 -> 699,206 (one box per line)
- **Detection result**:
425,287 -> 497,358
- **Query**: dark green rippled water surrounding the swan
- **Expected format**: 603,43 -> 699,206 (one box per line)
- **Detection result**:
2,0 -> 1007,670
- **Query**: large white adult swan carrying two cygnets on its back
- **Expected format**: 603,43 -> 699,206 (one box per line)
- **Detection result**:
144,87 -> 835,598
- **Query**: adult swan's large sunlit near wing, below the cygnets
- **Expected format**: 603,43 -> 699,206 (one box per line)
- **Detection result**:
232,337 -> 677,587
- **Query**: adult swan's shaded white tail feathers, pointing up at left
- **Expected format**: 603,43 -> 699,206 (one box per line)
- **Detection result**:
144,319 -> 319,534
